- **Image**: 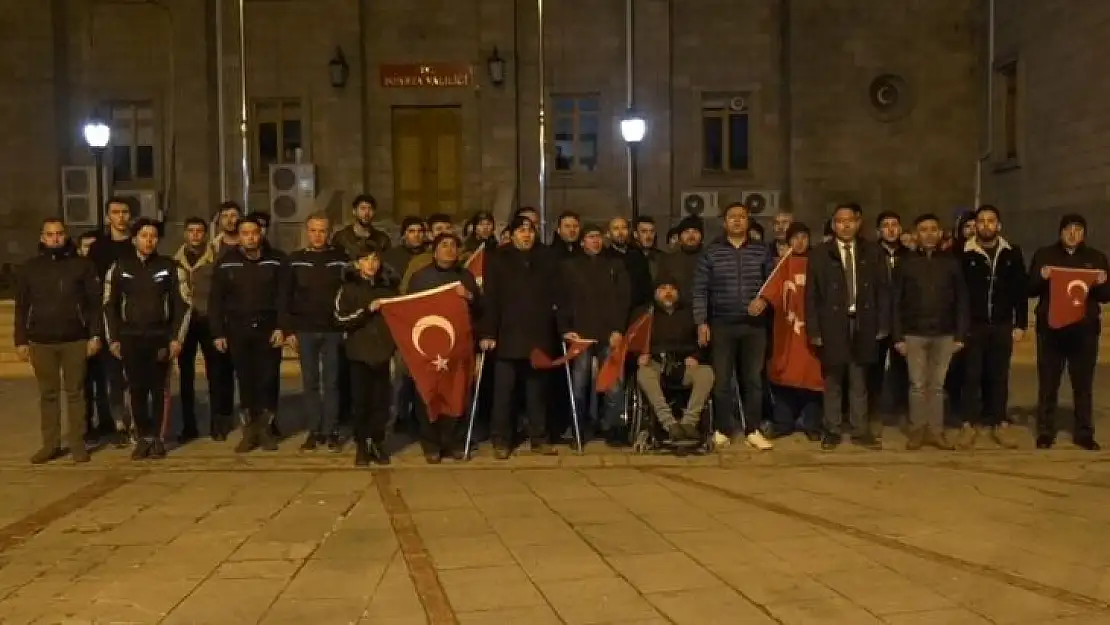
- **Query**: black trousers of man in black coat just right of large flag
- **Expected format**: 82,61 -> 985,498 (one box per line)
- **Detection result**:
490,359 -> 549,447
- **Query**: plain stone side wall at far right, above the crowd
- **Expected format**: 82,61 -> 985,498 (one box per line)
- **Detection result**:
983,0 -> 1110,254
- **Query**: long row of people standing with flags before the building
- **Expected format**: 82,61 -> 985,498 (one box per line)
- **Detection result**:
14,195 -> 1110,465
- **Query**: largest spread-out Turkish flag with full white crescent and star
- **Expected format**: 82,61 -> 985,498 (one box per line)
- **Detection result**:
381,282 -> 474,421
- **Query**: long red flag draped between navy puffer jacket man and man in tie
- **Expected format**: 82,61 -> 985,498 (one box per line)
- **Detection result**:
759,253 -> 825,391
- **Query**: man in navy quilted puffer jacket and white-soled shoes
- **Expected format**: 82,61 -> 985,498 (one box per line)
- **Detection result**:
693,202 -> 774,451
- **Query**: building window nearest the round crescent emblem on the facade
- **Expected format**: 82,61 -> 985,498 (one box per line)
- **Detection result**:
702,93 -> 751,172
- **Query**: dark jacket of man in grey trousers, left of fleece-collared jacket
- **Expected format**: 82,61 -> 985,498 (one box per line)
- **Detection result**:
890,250 -> 969,343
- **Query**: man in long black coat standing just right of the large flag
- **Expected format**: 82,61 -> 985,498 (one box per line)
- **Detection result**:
477,216 -> 557,460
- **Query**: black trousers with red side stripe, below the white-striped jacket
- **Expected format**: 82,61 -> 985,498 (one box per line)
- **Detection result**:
120,336 -> 170,438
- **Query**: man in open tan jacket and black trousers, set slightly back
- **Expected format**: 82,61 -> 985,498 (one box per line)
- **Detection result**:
173,217 -> 239,443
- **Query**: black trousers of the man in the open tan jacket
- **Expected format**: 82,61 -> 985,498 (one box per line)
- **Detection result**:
178,317 -> 235,432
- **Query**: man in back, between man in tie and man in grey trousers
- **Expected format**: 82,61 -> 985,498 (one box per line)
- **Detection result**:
867,211 -> 912,424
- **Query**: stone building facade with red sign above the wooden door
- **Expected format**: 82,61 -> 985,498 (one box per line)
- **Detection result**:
0,0 -> 981,255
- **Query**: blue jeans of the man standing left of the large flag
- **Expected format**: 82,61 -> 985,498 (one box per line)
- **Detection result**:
296,332 -> 343,435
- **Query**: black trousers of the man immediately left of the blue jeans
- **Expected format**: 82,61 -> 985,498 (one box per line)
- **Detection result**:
228,326 -> 281,420
